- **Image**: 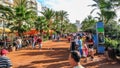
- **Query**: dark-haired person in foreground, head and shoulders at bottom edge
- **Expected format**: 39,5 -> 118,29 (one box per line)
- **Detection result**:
69,51 -> 84,68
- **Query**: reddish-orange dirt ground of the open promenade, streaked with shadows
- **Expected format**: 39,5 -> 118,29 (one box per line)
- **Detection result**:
7,39 -> 120,68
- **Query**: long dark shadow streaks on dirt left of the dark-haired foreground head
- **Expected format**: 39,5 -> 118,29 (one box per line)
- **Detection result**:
17,48 -> 70,68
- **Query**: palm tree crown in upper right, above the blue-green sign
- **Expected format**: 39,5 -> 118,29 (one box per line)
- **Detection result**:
91,0 -> 116,23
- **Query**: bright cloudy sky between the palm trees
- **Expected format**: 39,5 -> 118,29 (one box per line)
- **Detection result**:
37,0 -> 119,23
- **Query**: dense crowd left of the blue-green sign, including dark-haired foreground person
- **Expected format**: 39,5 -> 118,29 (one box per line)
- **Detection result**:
68,32 -> 94,68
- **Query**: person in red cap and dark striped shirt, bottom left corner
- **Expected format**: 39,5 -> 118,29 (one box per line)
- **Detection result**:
0,49 -> 12,68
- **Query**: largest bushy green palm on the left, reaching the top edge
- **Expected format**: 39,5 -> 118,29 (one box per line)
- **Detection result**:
11,0 -> 37,35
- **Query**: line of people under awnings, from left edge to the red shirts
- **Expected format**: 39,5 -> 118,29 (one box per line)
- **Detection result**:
0,35 -> 42,50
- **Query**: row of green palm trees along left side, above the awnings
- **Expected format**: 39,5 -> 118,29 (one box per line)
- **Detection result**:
0,0 -> 77,34
